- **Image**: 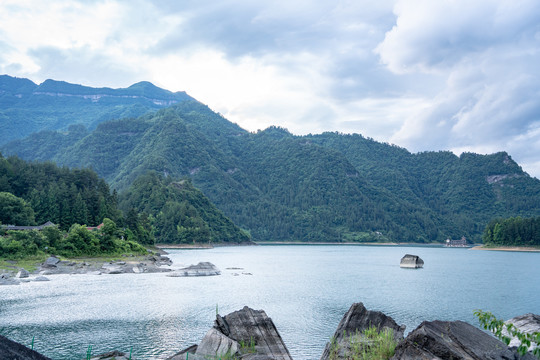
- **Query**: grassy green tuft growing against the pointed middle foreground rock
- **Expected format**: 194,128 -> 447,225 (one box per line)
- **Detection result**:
329,326 -> 397,360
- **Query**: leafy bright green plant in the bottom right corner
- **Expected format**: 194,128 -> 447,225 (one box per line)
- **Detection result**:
474,310 -> 540,359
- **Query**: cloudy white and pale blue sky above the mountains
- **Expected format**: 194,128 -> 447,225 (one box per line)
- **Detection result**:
0,0 -> 540,178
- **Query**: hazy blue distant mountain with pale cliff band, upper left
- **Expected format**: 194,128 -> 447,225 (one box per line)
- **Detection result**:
0,75 -> 192,145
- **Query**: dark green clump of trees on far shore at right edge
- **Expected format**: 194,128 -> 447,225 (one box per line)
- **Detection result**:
482,216 -> 540,247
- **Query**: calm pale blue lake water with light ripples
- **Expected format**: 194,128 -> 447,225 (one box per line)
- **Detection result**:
0,246 -> 540,360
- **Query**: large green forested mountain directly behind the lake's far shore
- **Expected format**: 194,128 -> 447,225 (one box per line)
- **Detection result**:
1,95 -> 540,242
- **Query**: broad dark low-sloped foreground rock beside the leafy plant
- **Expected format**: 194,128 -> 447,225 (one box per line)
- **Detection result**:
392,320 -> 535,360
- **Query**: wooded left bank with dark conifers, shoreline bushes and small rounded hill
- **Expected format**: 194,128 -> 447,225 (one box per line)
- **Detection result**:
0,154 -> 249,257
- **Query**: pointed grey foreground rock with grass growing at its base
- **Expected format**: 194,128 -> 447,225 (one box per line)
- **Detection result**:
321,303 -> 405,360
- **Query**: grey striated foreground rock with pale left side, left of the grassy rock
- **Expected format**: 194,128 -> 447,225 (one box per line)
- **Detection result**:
168,306 -> 292,360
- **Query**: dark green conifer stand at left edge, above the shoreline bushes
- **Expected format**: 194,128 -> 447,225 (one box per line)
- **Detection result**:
0,154 -> 121,230
